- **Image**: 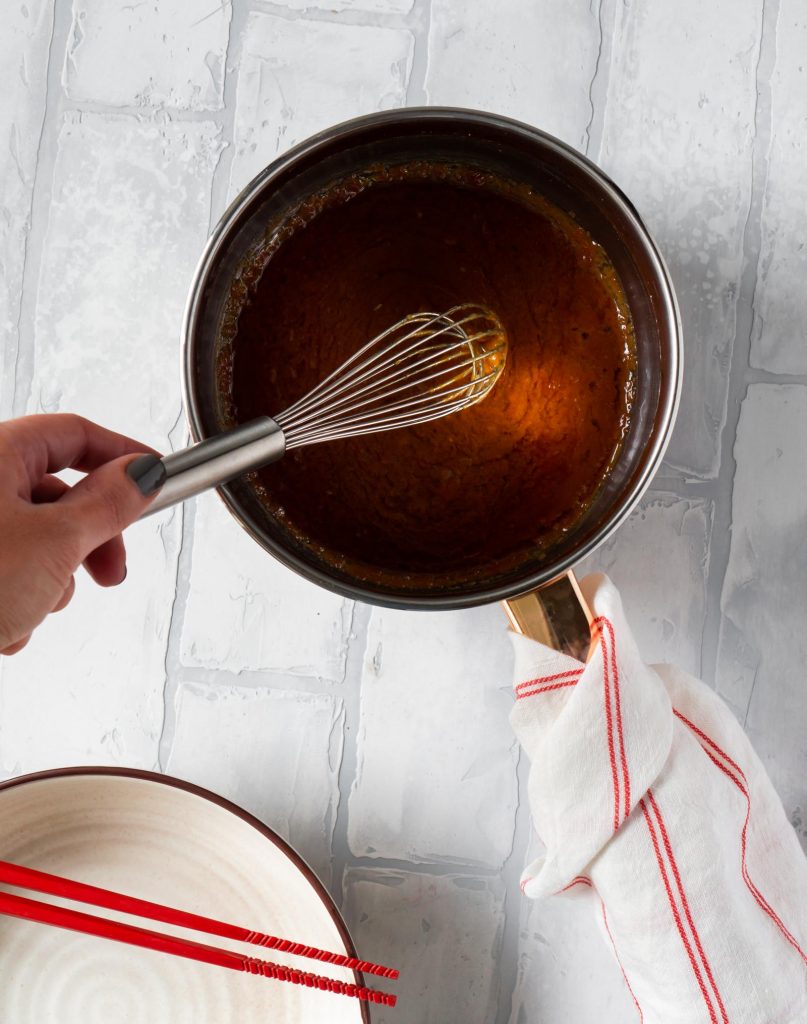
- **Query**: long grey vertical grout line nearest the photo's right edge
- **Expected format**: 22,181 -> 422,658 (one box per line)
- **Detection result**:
702,0 -> 779,685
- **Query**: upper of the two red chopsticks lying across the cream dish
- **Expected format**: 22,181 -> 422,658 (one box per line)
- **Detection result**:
0,860 -> 398,979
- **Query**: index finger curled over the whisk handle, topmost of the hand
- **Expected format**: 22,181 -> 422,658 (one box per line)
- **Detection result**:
0,413 -> 159,491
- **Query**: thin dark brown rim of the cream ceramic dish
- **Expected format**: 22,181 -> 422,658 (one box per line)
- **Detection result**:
0,765 -> 370,1024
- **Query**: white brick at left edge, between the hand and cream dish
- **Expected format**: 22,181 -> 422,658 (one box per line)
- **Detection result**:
0,521 -> 179,775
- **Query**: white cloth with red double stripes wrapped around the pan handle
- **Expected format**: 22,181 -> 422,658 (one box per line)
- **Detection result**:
511,575 -> 807,1024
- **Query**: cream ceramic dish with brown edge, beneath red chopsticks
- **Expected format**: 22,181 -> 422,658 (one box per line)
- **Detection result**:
0,768 -> 370,1024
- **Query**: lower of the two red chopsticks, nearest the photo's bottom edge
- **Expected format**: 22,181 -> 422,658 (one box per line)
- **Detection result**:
0,892 -> 396,1007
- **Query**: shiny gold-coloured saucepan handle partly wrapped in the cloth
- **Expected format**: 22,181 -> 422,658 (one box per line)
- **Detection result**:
502,570 -> 594,662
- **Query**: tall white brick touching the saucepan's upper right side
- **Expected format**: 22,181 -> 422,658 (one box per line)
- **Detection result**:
590,0 -> 761,476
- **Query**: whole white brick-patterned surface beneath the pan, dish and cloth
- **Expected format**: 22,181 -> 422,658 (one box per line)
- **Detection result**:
0,0 -> 807,1024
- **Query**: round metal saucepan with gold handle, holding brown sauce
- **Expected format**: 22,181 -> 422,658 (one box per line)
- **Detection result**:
182,108 -> 682,655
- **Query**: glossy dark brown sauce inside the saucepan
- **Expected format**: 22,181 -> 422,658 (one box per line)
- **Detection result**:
221,165 -> 635,581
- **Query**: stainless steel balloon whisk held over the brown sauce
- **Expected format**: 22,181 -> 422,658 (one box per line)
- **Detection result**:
145,303 -> 507,515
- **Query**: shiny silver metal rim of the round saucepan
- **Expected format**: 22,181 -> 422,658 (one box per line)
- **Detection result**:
180,106 -> 683,610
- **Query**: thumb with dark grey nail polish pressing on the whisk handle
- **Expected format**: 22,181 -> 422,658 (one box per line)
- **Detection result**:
57,455 -> 165,560
